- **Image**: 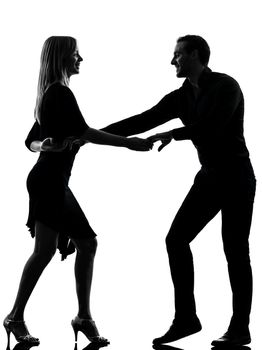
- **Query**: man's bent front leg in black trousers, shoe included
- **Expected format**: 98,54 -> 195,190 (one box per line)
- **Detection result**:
153,171 -> 221,344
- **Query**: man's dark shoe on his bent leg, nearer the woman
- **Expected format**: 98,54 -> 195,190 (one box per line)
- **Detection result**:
153,317 -> 202,345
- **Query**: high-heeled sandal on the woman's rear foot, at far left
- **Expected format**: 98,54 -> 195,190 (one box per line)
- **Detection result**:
3,316 -> 40,347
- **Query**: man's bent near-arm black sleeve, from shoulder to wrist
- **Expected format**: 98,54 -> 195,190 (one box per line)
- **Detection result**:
172,77 -> 244,141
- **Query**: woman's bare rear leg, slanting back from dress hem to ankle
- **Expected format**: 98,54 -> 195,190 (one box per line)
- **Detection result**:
9,221 -> 58,320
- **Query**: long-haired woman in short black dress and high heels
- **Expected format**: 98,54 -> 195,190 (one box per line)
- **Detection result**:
4,36 -> 152,344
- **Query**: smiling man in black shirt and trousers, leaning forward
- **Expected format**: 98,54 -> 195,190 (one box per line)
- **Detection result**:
103,35 -> 256,346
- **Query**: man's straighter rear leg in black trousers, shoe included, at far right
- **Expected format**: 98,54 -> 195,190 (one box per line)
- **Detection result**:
212,171 -> 255,345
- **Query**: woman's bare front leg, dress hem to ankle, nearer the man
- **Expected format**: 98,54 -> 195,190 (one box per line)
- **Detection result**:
72,238 -> 97,319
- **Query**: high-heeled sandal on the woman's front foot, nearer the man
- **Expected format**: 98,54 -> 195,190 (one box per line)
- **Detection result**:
71,316 -> 109,345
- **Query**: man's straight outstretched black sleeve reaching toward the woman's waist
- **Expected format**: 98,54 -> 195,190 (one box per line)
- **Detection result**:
102,90 -> 179,136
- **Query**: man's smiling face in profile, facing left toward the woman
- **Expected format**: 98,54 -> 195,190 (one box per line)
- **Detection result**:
171,41 -> 191,78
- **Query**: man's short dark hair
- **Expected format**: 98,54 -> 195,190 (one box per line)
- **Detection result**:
177,35 -> 210,66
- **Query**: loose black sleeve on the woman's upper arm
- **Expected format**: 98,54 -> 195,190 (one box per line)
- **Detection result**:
41,85 -> 89,141
